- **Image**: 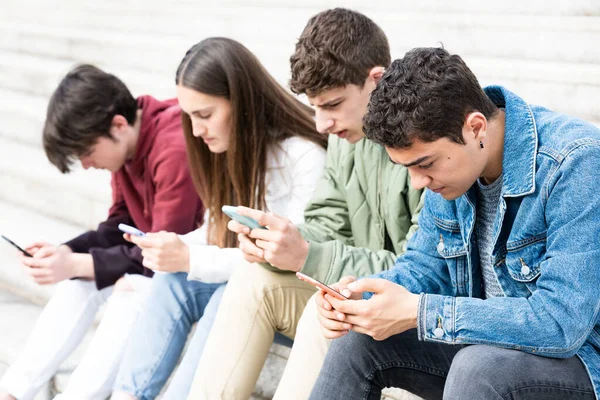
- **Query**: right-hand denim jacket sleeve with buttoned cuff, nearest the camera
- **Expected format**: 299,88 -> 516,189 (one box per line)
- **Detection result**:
418,144 -> 600,358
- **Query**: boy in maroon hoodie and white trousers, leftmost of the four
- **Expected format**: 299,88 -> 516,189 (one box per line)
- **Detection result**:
0,65 -> 203,400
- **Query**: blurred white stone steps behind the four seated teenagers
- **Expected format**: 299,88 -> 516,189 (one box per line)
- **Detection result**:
0,0 -> 600,398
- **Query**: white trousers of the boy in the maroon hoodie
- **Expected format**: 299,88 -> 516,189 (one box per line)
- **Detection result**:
0,275 -> 151,400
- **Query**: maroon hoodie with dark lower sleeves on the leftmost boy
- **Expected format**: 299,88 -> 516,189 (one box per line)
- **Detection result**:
66,96 -> 203,289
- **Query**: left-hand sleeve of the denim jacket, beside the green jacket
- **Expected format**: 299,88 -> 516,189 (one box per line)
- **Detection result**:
363,191 -> 454,299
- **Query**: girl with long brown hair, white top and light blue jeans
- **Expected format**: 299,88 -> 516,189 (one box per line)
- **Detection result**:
113,38 -> 326,399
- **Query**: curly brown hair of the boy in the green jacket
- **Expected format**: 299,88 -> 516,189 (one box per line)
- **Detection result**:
290,8 -> 392,96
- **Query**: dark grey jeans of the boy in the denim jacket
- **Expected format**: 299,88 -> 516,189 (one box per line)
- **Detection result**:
310,330 -> 595,400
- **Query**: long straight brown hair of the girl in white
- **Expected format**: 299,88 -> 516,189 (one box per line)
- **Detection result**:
176,37 -> 327,247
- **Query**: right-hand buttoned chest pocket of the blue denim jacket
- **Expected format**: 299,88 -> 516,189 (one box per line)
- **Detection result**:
506,234 -> 546,282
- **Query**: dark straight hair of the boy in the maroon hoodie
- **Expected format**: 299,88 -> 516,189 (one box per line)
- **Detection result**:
42,64 -> 137,173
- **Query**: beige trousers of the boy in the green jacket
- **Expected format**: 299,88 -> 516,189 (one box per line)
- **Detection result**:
189,264 -> 328,400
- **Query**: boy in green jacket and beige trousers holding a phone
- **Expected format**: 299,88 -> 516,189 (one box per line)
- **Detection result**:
190,9 -> 421,399
